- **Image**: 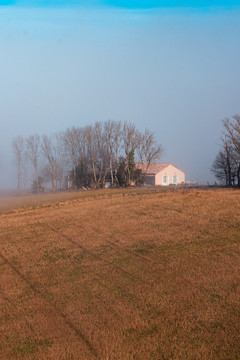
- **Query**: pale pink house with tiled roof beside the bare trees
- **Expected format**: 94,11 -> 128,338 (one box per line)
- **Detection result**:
136,163 -> 185,186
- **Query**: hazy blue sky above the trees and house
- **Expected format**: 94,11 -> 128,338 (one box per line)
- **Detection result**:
0,0 -> 240,187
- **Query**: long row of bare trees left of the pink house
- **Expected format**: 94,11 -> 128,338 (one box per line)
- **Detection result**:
12,120 -> 162,192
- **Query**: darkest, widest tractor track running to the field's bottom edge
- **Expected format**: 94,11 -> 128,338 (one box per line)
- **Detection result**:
0,252 -> 100,359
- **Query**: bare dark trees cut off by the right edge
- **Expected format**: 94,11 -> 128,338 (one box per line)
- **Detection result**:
211,114 -> 240,187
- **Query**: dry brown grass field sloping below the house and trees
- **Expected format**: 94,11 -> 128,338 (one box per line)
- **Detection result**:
0,189 -> 240,360
